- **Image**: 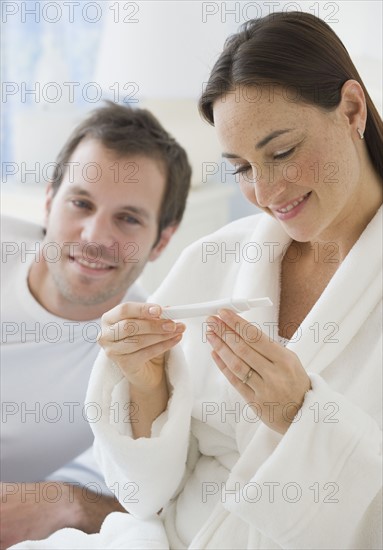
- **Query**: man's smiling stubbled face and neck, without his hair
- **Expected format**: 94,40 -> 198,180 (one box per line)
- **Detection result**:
31,139 -> 173,320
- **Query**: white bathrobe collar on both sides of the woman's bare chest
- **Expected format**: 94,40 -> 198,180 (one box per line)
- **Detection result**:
233,207 -> 382,373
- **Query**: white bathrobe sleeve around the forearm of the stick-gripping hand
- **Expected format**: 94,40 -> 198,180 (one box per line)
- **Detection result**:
87,348 -> 191,519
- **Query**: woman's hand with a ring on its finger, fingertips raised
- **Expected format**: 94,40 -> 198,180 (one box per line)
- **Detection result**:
207,309 -> 311,434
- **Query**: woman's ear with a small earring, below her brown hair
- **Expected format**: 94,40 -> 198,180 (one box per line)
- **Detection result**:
340,80 -> 367,136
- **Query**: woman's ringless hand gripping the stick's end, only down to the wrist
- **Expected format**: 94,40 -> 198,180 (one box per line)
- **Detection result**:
98,302 -> 185,393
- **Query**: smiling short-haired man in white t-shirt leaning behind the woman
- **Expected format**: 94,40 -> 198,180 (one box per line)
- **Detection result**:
1,102 -> 191,548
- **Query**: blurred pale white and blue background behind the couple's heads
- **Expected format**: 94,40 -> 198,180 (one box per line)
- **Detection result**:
1,0 -> 382,291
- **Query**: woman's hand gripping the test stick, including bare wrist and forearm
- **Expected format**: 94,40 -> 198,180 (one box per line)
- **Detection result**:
99,302 -> 185,438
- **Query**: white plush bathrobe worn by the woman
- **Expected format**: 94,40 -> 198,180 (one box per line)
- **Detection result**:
11,209 -> 382,550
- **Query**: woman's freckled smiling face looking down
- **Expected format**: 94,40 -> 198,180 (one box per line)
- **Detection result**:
214,86 -> 363,242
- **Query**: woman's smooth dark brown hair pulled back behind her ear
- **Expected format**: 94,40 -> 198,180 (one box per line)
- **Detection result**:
199,12 -> 383,177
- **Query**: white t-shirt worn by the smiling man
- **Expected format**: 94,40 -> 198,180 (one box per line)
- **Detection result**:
0,218 -> 145,482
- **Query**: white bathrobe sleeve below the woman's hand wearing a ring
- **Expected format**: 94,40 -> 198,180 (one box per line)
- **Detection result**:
225,370 -> 382,549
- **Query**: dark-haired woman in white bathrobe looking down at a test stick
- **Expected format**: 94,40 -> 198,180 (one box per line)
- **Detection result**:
12,13 -> 382,549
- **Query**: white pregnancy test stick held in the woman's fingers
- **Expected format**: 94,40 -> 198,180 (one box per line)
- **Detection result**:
162,298 -> 273,320
